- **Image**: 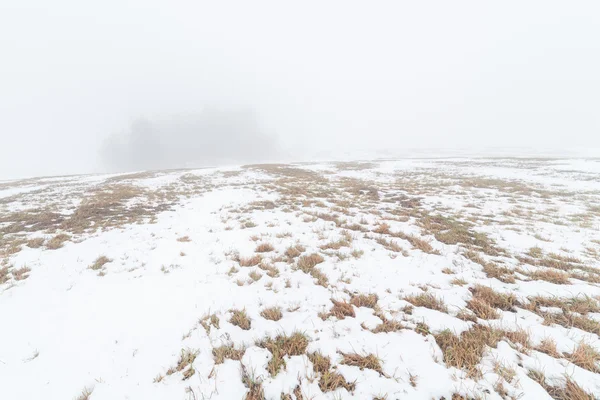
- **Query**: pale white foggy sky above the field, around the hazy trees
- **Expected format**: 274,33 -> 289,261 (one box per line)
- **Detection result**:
0,0 -> 600,178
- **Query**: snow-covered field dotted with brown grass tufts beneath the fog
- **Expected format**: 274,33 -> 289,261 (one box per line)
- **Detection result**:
0,158 -> 600,400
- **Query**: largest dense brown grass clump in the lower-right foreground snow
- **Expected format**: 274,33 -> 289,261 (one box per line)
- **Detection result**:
435,325 -> 503,377
